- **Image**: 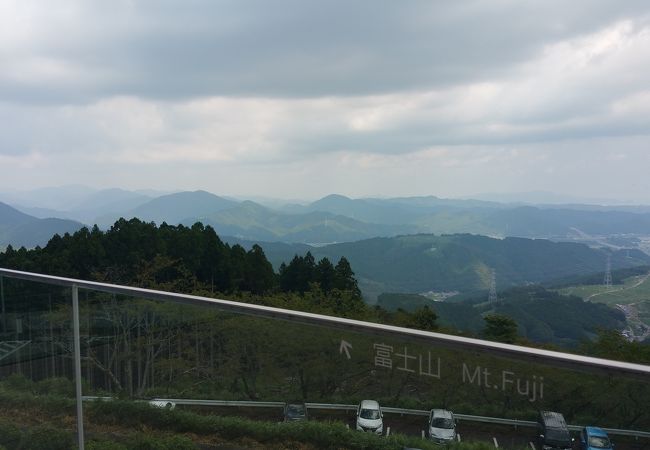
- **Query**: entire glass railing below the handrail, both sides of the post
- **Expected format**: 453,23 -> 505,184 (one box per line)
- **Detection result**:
0,268 -> 650,450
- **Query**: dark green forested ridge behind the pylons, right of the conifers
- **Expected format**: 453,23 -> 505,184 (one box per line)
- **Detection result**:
235,234 -> 650,301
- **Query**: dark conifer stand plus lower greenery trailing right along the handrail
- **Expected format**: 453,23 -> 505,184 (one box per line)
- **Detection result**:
0,219 -> 437,330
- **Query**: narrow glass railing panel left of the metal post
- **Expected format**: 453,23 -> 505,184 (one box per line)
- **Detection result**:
0,277 -> 77,449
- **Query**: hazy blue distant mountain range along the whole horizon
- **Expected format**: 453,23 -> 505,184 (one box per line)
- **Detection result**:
0,187 -> 650,248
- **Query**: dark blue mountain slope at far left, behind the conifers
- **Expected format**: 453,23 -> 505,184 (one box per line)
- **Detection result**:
0,202 -> 83,248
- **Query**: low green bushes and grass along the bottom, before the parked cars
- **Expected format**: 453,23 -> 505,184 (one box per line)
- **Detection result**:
0,388 -> 490,450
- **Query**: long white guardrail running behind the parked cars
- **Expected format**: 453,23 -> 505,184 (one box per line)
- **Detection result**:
139,397 -> 650,439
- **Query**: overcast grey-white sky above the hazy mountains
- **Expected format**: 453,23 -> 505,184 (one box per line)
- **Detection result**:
0,0 -> 650,203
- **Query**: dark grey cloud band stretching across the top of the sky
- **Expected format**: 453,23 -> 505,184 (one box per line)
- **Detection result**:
0,0 -> 648,103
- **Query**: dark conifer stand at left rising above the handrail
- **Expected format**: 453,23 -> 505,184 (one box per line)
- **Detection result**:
0,219 -> 360,296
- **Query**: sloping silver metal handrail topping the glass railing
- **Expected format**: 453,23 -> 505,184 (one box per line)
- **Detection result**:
0,268 -> 650,380
